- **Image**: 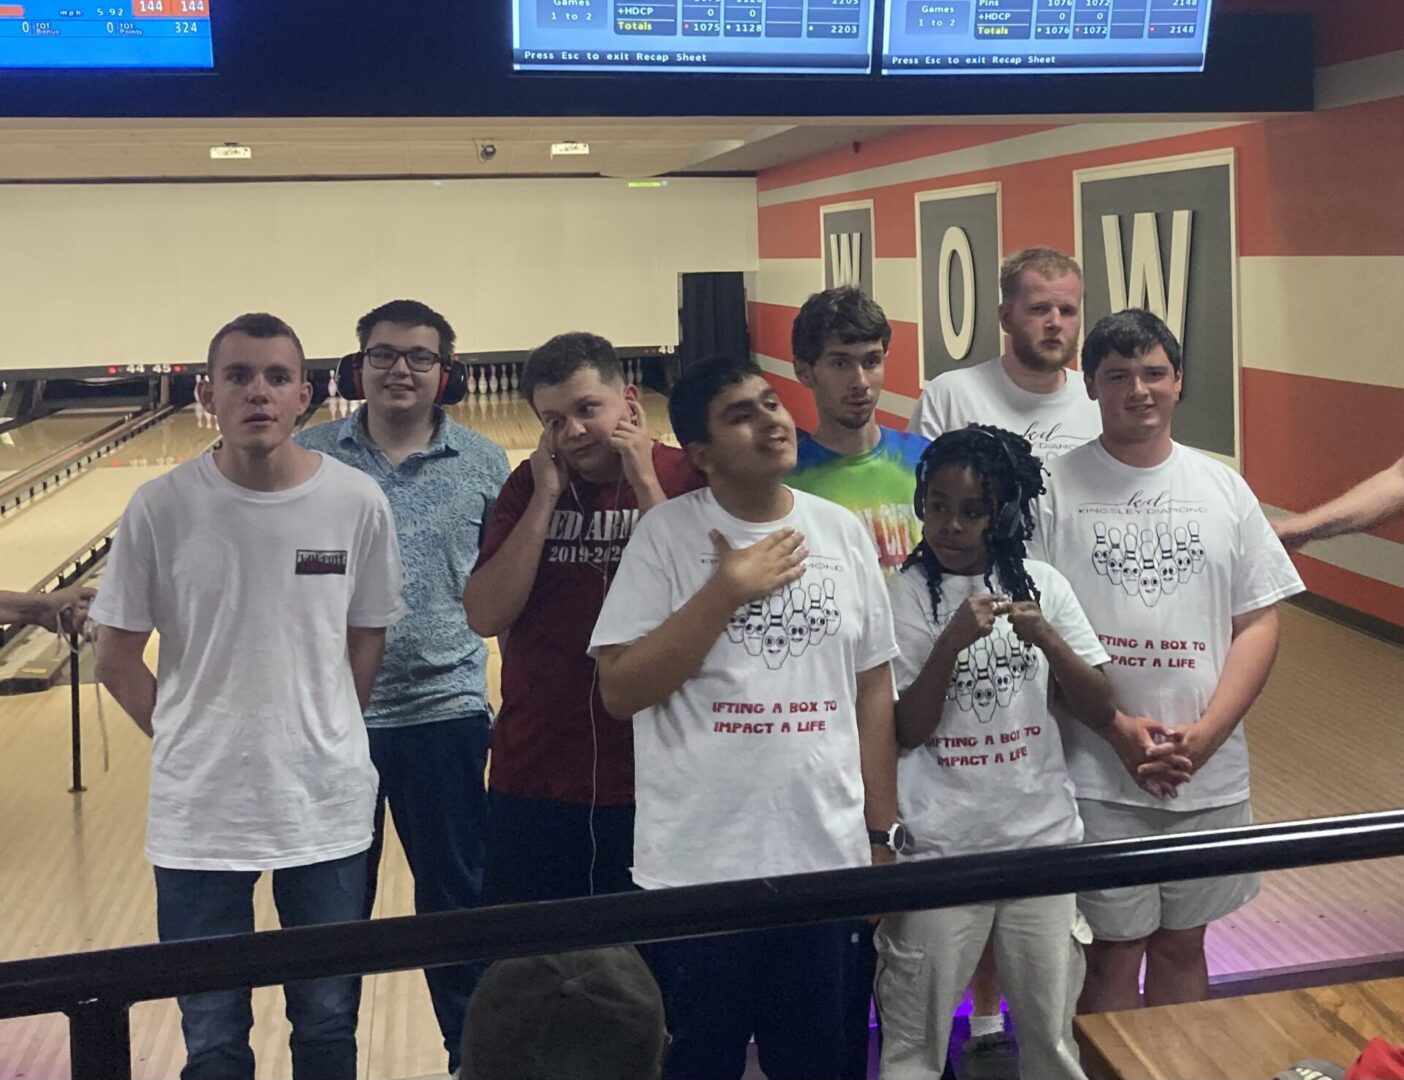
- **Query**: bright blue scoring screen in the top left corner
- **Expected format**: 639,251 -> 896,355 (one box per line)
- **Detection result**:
0,0 -> 215,70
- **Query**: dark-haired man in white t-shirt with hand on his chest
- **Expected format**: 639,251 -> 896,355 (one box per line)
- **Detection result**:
591,360 -> 904,1080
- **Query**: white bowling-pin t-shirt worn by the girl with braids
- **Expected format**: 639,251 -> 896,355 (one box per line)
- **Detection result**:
887,560 -> 1108,858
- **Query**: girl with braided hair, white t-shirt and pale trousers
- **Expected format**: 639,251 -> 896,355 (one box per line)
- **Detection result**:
876,424 -> 1116,1080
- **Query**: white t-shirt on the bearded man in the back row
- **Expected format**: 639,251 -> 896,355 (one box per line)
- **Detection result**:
907,357 -> 1102,465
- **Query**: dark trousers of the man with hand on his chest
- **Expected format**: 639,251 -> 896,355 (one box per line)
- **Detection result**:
640,923 -> 854,1080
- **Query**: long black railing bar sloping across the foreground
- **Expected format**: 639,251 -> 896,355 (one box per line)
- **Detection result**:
0,810 -> 1404,1018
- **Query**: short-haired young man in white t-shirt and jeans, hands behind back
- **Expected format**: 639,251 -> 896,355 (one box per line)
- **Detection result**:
91,315 -> 404,1080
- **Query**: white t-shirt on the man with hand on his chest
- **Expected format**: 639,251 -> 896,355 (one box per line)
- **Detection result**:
590,489 -> 897,889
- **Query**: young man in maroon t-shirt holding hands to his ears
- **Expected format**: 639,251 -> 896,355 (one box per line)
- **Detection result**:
463,333 -> 705,903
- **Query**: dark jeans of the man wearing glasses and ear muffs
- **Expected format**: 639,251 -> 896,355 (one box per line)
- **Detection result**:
364,712 -> 491,1073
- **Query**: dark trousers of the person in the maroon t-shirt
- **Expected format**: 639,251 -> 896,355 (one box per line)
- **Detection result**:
483,791 -> 633,904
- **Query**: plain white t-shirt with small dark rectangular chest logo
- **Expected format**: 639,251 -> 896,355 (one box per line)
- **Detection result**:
93,455 -> 404,869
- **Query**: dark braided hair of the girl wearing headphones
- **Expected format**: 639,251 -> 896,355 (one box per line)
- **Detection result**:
901,424 -> 1045,619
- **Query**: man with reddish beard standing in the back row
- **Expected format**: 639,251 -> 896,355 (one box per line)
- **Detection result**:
907,247 -> 1102,463
